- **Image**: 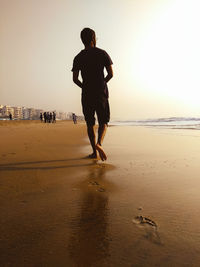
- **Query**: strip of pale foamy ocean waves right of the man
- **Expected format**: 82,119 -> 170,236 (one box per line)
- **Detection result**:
109,117 -> 200,130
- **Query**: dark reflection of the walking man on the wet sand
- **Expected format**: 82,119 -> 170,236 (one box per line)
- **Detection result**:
69,165 -> 109,267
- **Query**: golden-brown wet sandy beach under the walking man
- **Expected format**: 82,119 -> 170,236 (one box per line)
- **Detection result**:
0,121 -> 200,267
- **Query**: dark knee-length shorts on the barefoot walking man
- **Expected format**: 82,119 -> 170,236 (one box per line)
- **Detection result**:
82,95 -> 110,125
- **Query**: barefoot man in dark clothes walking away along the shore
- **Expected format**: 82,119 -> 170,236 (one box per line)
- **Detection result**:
72,28 -> 113,161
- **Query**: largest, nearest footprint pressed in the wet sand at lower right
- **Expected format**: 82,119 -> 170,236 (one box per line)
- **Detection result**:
133,215 -> 163,245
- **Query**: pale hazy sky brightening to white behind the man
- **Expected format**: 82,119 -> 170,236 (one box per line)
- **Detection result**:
0,0 -> 200,120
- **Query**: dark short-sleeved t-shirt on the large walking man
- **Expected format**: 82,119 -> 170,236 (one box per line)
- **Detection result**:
72,47 -> 113,98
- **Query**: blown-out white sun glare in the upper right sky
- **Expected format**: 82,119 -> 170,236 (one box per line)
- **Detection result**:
134,1 -> 200,106
